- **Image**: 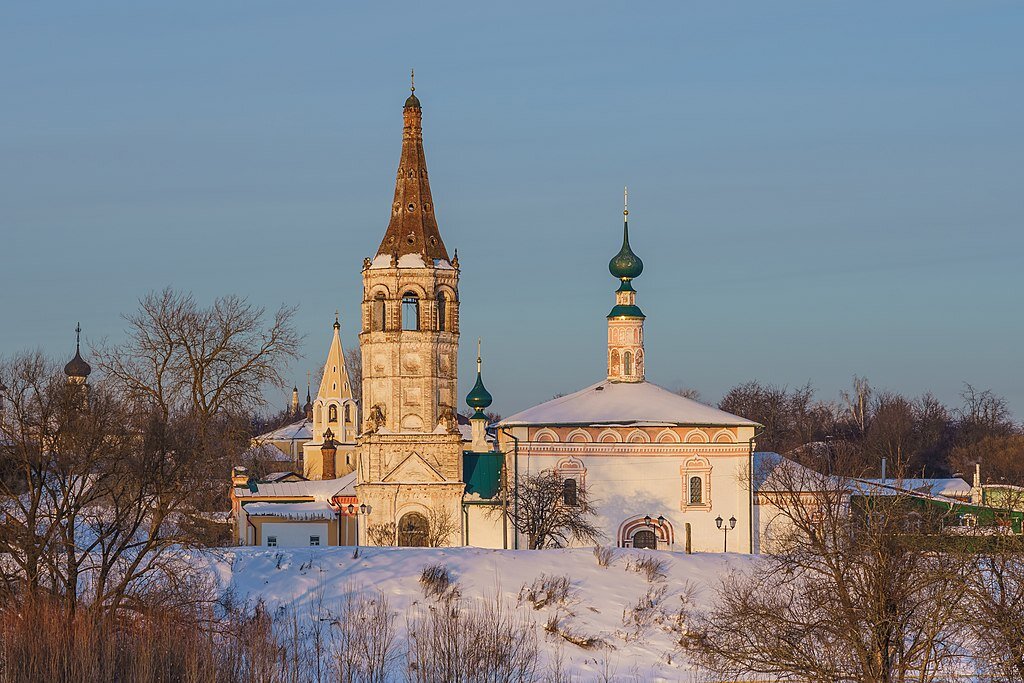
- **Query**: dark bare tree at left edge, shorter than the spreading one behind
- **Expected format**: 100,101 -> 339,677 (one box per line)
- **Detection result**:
0,353 -> 209,613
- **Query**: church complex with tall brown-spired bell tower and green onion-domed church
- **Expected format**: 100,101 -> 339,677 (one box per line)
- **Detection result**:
231,82 -> 760,552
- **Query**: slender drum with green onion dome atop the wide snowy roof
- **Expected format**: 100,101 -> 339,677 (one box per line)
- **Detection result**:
608,189 -> 645,382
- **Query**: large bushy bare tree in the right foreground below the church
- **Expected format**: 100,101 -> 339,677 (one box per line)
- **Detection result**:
686,448 -> 967,683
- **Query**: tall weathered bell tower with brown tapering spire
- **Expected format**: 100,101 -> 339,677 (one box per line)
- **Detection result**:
356,78 -> 465,545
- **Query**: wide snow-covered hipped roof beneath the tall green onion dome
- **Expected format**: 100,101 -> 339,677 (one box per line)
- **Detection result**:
500,380 -> 757,427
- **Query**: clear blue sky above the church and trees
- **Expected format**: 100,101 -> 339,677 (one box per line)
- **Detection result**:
0,0 -> 1024,420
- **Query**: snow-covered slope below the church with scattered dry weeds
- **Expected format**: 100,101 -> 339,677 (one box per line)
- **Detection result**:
199,548 -> 757,681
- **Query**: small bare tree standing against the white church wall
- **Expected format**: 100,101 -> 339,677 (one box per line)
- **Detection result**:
495,471 -> 601,550
